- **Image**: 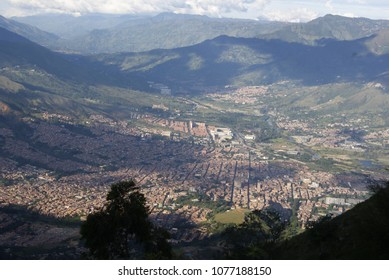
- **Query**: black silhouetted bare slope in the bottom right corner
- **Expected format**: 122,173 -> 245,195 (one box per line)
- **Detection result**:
273,185 -> 389,260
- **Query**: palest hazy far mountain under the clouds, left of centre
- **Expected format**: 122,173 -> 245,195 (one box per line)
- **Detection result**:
52,13 -> 286,54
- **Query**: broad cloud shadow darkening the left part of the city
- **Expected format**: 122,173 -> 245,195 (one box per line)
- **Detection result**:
0,116 -> 211,176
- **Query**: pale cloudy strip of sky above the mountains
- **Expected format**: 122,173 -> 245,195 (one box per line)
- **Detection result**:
0,0 -> 389,22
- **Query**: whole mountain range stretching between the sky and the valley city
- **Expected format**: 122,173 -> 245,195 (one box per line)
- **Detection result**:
0,14 -> 389,116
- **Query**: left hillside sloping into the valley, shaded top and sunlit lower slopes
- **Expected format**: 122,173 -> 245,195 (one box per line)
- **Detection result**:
0,27 -> 150,116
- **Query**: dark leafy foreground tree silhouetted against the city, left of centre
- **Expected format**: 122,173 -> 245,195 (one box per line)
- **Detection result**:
81,181 -> 171,259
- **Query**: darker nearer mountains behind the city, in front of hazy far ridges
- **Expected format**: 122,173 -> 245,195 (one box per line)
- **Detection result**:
0,23 -> 389,119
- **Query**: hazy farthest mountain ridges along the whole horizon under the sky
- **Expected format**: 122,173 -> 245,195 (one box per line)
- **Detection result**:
10,13 -> 389,54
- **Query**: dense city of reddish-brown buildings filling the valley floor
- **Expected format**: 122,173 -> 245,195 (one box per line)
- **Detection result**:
0,83 -> 389,249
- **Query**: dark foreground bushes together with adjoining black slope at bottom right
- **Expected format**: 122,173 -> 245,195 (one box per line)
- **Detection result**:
219,184 -> 389,260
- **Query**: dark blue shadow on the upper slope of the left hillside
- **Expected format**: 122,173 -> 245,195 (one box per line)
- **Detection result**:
0,27 -> 146,88
